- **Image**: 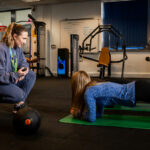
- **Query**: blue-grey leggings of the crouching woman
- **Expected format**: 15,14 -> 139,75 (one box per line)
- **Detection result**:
0,70 -> 36,103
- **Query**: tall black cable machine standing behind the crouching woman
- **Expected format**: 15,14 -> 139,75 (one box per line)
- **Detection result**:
17,14 -> 54,77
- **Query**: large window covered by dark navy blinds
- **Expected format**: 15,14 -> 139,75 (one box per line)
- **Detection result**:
103,0 -> 148,49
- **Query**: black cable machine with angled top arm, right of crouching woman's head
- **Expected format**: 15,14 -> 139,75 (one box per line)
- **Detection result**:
16,14 -> 54,77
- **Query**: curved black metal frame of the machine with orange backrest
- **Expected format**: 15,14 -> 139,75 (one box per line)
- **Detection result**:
79,24 -> 128,78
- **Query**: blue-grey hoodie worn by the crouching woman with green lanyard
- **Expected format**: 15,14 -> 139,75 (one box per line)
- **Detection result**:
0,43 -> 29,84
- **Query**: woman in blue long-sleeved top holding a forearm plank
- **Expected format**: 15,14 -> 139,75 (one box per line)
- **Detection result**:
70,71 -> 150,122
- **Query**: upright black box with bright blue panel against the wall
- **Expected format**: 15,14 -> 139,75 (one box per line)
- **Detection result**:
57,48 -> 69,77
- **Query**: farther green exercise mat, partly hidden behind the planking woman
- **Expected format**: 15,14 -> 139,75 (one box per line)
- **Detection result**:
105,103 -> 150,112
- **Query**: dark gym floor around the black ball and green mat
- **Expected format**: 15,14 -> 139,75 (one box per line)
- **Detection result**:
0,78 -> 150,150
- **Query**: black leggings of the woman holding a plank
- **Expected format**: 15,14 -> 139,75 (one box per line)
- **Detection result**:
135,79 -> 150,102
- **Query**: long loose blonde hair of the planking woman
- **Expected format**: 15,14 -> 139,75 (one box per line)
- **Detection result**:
70,71 -> 96,118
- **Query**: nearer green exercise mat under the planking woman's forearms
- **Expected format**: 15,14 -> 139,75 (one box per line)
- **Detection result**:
59,114 -> 150,129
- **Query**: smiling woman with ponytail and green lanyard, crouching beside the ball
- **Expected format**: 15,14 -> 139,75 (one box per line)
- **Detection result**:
0,23 -> 36,113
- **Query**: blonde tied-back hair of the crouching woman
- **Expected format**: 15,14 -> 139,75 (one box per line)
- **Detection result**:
1,22 -> 27,47
